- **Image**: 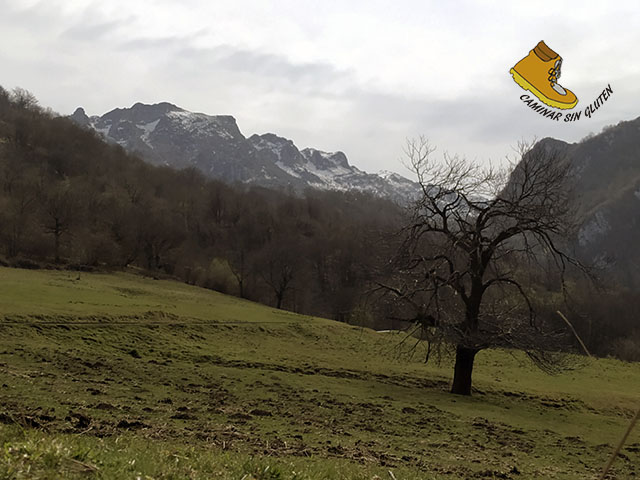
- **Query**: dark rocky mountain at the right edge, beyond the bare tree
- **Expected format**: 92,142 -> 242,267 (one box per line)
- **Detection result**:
537,118 -> 640,289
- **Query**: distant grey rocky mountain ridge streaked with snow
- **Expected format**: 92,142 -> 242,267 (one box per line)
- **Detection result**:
71,103 -> 418,203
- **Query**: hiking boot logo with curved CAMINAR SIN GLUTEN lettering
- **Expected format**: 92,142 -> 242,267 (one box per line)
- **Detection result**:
509,40 -> 613,122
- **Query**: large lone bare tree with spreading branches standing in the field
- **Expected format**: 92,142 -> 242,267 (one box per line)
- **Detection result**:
381,138 -> 578,395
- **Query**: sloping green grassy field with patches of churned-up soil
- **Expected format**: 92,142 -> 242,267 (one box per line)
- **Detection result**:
0,268 -> 640,480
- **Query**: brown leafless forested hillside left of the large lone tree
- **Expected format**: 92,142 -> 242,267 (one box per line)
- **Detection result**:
0,85 -> 402,324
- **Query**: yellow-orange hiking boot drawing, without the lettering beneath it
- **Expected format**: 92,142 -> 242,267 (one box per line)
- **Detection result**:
509,41 -> 578,110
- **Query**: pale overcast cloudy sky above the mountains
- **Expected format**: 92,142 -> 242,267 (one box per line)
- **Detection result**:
0,0 -> 640,175
